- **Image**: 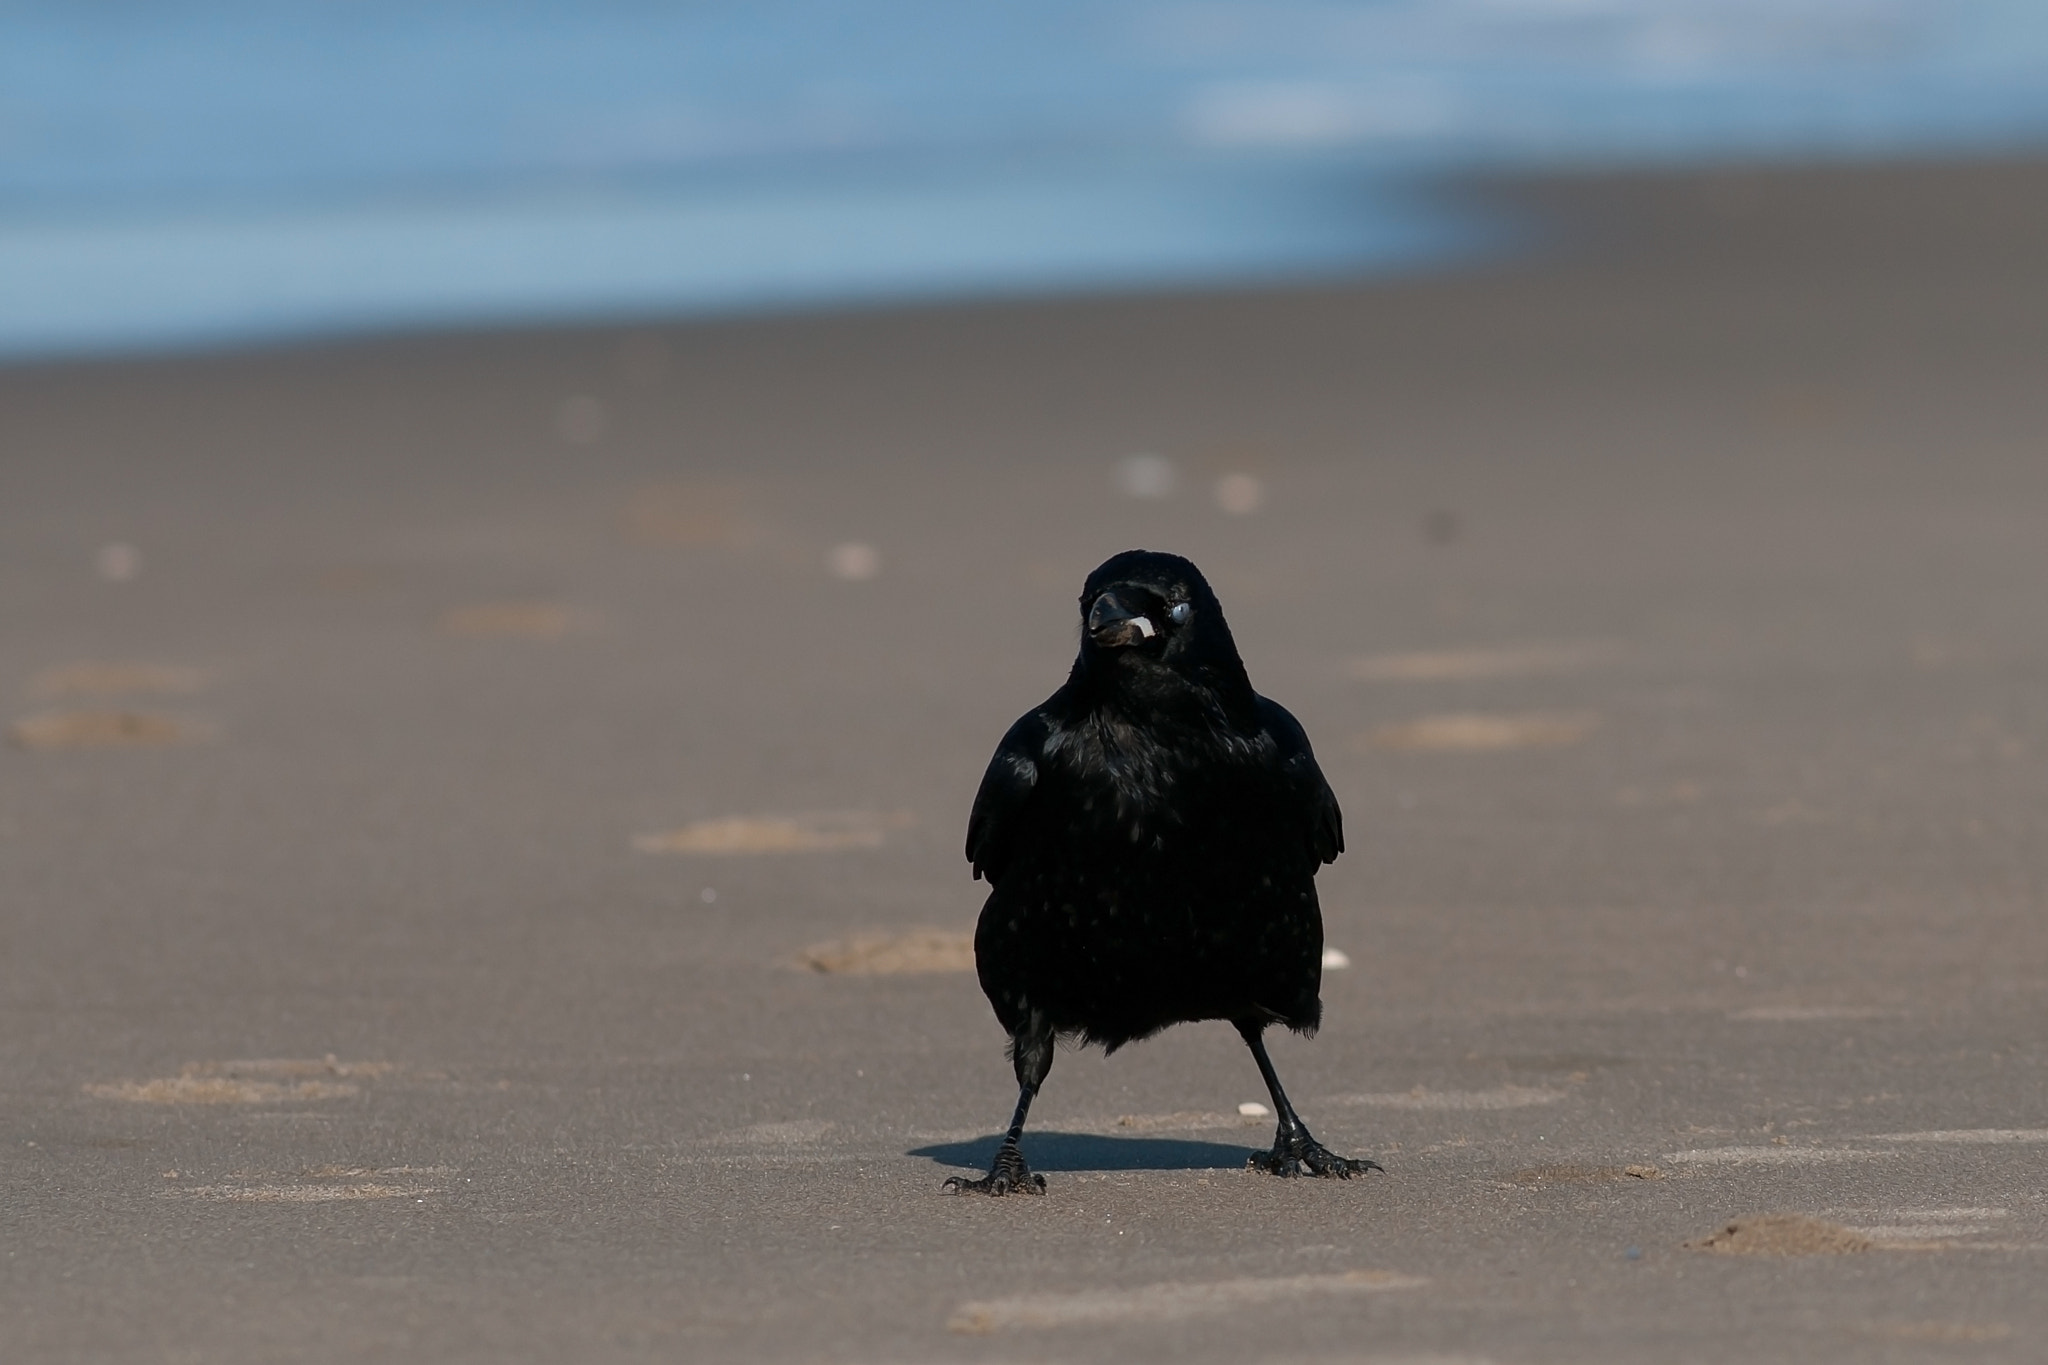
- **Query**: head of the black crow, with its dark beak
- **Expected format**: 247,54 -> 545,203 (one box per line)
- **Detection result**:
1081,551 -> 1243,684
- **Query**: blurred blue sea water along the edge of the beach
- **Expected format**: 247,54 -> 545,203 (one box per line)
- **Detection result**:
0,0 -> 2048,356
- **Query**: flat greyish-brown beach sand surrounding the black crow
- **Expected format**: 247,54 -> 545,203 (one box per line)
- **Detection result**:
0,164 -> 2048,1365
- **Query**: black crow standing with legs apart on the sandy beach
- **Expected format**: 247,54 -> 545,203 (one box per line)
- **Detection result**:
946,551 -> 1380,1195
